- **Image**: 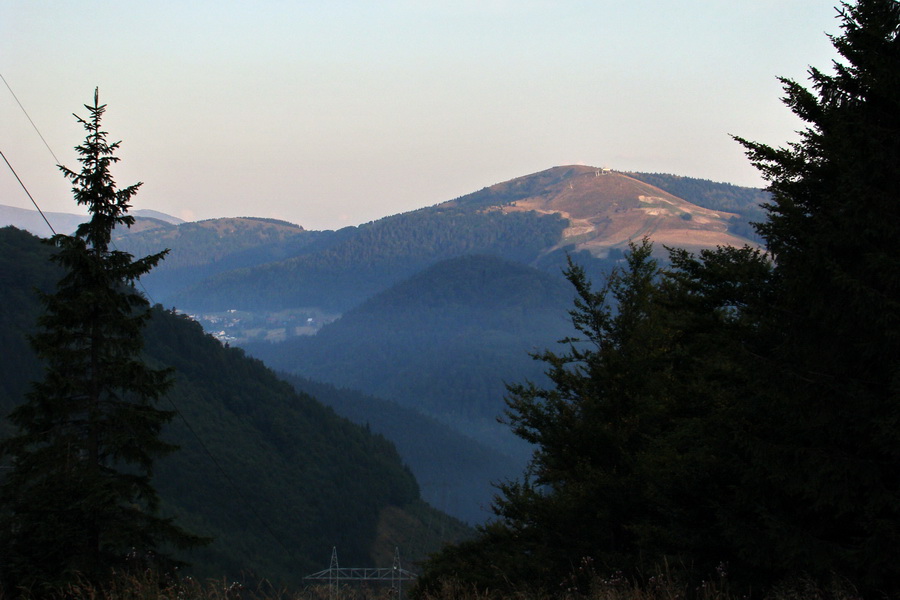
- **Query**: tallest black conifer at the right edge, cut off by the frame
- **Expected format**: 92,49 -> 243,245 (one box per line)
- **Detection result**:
740,0 -> 900,592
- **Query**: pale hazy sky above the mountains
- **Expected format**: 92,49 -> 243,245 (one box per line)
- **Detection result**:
0,0 -> 839,229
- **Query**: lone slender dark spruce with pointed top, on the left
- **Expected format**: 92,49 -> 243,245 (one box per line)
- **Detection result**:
0,92 -> 204,593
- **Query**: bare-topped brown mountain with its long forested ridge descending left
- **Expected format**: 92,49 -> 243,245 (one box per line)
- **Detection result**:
149,166 -> 765,312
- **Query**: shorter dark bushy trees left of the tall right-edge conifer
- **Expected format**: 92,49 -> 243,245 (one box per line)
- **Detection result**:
420,240 -> 772,590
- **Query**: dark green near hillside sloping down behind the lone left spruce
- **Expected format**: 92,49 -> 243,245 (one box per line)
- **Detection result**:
0,228 -> 462,584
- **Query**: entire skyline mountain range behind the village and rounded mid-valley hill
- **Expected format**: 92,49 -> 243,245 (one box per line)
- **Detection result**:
0,166 -> 767,312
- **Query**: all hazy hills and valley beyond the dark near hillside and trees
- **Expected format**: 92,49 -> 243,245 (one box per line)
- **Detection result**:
0,166 -> 768,522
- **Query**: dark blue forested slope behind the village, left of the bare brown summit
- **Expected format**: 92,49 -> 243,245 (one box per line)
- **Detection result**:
172,208 -> 565,311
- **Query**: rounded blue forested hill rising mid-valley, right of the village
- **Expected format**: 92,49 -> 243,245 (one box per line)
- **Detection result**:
248,256 -> 571,426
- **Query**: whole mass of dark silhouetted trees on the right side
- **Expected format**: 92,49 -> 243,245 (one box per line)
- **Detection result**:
421,0 -> 900,596
